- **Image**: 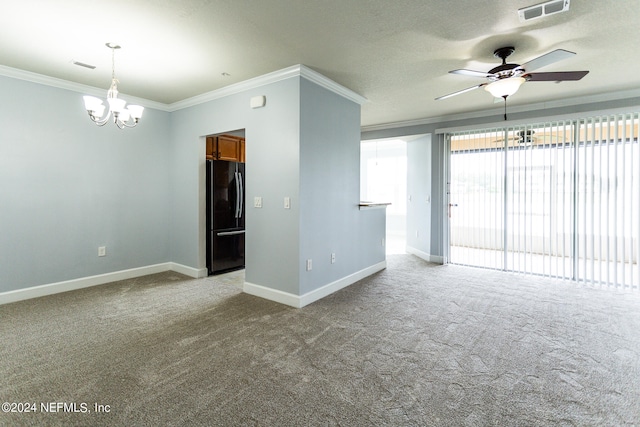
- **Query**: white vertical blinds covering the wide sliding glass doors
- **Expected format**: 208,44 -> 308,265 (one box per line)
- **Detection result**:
447,113 -> 640,290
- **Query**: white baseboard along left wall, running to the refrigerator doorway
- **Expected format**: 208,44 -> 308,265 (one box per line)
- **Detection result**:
0,262 -> 207,305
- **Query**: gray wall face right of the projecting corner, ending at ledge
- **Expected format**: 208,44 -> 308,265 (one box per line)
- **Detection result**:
298,79 -> 385,295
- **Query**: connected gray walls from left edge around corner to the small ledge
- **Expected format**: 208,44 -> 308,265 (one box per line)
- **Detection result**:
0,70 -> 384,302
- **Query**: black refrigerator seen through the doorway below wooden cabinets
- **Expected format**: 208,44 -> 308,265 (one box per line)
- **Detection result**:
207,160 -> 245,275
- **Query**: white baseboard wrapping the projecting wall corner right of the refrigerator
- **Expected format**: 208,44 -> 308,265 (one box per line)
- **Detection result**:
243,261 -> 387,308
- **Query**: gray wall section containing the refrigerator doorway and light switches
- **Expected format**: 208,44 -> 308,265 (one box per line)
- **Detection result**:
170,78 -> 300,293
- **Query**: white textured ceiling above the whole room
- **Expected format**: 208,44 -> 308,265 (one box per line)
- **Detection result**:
0,0 -> 640,126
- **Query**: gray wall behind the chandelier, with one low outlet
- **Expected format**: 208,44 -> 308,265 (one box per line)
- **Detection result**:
0,76 -> 170,292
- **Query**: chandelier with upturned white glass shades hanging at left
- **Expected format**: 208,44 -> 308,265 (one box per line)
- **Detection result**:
83,43 -> 144,129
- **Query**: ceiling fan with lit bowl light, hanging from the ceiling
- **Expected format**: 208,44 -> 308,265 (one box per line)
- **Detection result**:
436,46 -> 589,120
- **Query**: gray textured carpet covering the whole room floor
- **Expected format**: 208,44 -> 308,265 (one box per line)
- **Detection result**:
0,255 -> 640,426
